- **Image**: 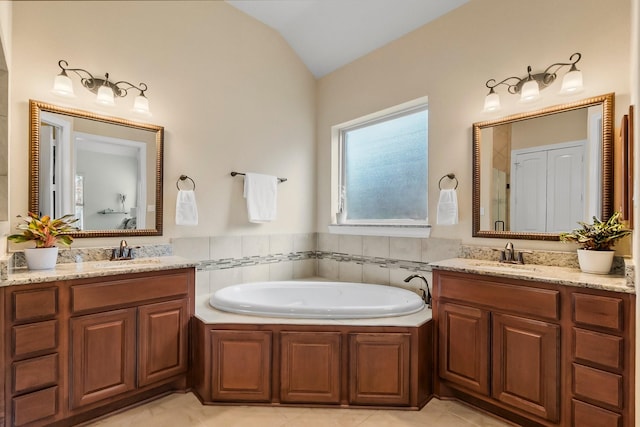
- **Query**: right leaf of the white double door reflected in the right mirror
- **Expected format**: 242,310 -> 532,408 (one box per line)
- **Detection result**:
546,144 -> 585,233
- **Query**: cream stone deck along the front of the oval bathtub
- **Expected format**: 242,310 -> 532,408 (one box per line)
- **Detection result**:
196,294 -> 431,327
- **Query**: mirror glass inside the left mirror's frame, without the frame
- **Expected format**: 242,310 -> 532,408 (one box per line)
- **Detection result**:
39,112 -> 154,230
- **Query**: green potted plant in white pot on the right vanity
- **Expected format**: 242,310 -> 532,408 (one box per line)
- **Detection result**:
560,212 -> 631,274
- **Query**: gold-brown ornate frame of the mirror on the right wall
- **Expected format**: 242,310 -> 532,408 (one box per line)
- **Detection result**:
472,93 -> 615,240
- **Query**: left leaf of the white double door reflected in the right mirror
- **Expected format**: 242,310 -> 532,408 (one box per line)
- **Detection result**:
511,151 -> 547,233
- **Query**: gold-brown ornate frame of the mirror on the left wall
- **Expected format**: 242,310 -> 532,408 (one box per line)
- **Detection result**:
29,100 -> 164,237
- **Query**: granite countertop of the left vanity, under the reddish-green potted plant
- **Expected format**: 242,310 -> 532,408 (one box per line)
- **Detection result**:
0,256 -> 198,286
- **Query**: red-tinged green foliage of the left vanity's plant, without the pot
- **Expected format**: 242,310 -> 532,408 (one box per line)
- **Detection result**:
7,212 -> 78,248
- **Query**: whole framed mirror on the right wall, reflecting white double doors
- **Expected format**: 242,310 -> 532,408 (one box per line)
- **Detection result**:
473,93 -> 614,240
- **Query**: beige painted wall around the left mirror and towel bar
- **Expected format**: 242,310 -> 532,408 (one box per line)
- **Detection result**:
10,1 -> 315,247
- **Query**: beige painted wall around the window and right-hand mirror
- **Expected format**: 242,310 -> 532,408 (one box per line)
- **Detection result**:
317,0 -> 630,250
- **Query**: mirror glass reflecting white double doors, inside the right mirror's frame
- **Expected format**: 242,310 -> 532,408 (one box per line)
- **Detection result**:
480,106 -> 602,233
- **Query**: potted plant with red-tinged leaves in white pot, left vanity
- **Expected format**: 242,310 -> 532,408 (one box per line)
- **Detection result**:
8,212 -> 78,270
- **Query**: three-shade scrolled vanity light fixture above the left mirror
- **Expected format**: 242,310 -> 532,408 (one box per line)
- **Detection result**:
51,59 -> 151,116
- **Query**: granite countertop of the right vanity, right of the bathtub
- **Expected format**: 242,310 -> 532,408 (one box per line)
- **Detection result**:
430,258 -> 636,294
